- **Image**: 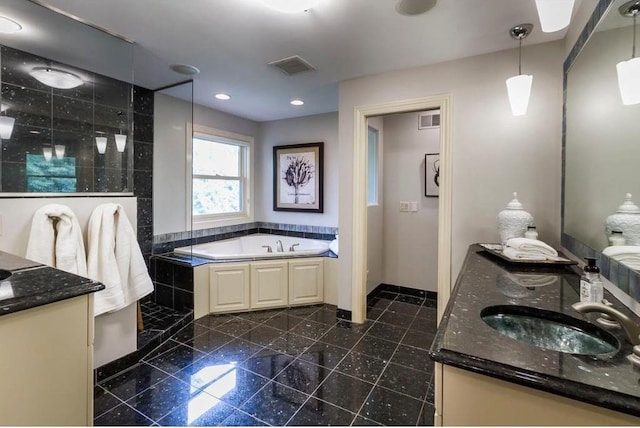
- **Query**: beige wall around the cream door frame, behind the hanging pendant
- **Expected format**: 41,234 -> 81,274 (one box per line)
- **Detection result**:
338,41 -> 564,309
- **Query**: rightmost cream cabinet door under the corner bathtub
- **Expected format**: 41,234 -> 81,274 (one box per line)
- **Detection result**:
289,258 -> 324,305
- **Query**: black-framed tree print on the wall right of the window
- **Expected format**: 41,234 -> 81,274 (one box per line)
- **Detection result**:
273,142 -> 324,213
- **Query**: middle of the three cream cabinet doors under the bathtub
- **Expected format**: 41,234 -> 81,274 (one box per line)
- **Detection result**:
251,261 -> 289,309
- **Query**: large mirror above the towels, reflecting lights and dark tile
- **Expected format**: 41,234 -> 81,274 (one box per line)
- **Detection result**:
0,0 -> 134,196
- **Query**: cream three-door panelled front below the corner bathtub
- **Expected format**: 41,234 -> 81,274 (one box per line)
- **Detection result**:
194,257 -> 324,319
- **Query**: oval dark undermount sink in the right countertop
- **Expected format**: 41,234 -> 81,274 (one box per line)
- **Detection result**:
480,305 -> 620,355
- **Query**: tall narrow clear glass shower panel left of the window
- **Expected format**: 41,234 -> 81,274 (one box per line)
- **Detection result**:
153,81 -> 193,251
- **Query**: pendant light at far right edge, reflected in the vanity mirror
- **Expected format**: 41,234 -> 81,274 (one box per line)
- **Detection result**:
616,0 -> 640,106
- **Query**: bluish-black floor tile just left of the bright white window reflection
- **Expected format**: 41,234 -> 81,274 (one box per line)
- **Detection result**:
126,377 -> 191,421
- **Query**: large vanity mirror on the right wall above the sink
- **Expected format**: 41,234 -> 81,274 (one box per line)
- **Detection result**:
562,0 -> 640,292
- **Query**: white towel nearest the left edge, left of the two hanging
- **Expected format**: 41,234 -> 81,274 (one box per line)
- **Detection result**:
25,204 -> 87,276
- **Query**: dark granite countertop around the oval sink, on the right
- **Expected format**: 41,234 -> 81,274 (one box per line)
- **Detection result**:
430,245 -> 640,416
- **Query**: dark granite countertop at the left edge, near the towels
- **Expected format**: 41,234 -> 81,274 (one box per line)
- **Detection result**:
0,251 -> 104,316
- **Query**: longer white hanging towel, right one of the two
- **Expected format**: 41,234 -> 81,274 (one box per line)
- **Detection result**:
87,204 -> 153,315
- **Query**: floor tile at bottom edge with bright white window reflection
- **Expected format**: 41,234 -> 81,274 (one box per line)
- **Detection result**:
158,392 -> 236,426
